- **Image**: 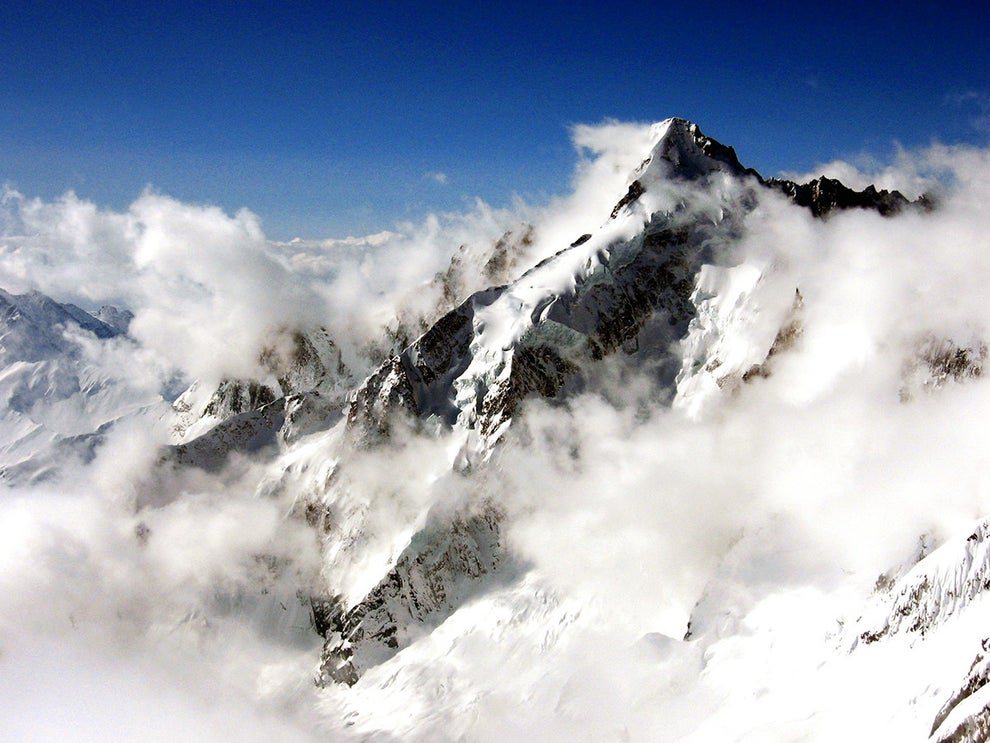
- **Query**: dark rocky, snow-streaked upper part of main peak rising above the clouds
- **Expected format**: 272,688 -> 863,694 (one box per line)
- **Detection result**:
350,119 -> 924,448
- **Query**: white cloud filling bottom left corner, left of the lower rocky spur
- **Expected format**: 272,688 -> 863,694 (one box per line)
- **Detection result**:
0,462 -> 330,741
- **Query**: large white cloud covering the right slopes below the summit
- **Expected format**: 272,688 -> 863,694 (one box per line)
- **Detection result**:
308,137 -> 990,740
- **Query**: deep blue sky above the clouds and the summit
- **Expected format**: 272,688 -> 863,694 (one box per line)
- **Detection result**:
0,0 -> 990,239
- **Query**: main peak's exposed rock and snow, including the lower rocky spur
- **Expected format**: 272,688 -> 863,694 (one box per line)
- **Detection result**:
292,119 -> 928,683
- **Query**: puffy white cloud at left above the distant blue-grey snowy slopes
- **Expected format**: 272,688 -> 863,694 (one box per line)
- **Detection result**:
0,191 -> 334,379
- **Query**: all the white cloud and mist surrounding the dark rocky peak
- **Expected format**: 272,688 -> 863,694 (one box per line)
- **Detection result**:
0,122 -> 990,740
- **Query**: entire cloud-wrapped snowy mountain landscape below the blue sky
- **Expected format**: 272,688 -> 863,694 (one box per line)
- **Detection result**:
0,118 -> 990,741
